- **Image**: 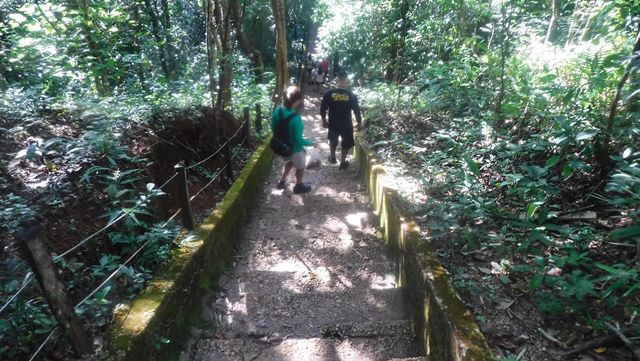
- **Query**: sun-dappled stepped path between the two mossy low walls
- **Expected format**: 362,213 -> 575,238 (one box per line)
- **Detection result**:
181,91 -> 424,361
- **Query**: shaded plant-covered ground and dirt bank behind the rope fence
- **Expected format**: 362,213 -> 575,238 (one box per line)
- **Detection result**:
0,103 -> 257,360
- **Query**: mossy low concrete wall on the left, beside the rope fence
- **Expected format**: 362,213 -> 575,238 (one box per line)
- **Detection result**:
107,136 -> 273,361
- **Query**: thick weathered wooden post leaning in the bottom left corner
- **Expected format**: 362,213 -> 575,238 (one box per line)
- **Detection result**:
18,226 -> 92,356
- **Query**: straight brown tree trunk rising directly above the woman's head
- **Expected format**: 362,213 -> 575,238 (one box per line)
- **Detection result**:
271,0 -> 289,105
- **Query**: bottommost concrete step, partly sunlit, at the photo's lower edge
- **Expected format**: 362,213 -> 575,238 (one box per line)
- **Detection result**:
188,320 -> 420,361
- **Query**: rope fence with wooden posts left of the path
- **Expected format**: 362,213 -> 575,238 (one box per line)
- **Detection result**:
0,105 -> 262,361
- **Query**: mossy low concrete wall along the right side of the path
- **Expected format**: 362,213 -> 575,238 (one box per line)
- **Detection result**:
355,139 -> 492,361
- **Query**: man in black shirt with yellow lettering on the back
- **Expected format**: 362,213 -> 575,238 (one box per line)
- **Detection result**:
320,73 -> 362,169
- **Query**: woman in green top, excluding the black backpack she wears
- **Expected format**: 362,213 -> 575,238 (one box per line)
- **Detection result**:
271,86 -> 314,194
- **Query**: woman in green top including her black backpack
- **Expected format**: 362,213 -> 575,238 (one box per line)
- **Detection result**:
271,86 -> 314,194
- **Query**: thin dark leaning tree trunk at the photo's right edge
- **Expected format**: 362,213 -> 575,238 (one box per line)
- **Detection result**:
596,25 -> 640,179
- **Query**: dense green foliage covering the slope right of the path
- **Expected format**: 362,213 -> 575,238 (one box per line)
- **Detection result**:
350,0 -> 640,334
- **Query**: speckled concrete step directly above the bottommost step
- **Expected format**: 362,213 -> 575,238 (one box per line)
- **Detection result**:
203,288 -> 406,337
